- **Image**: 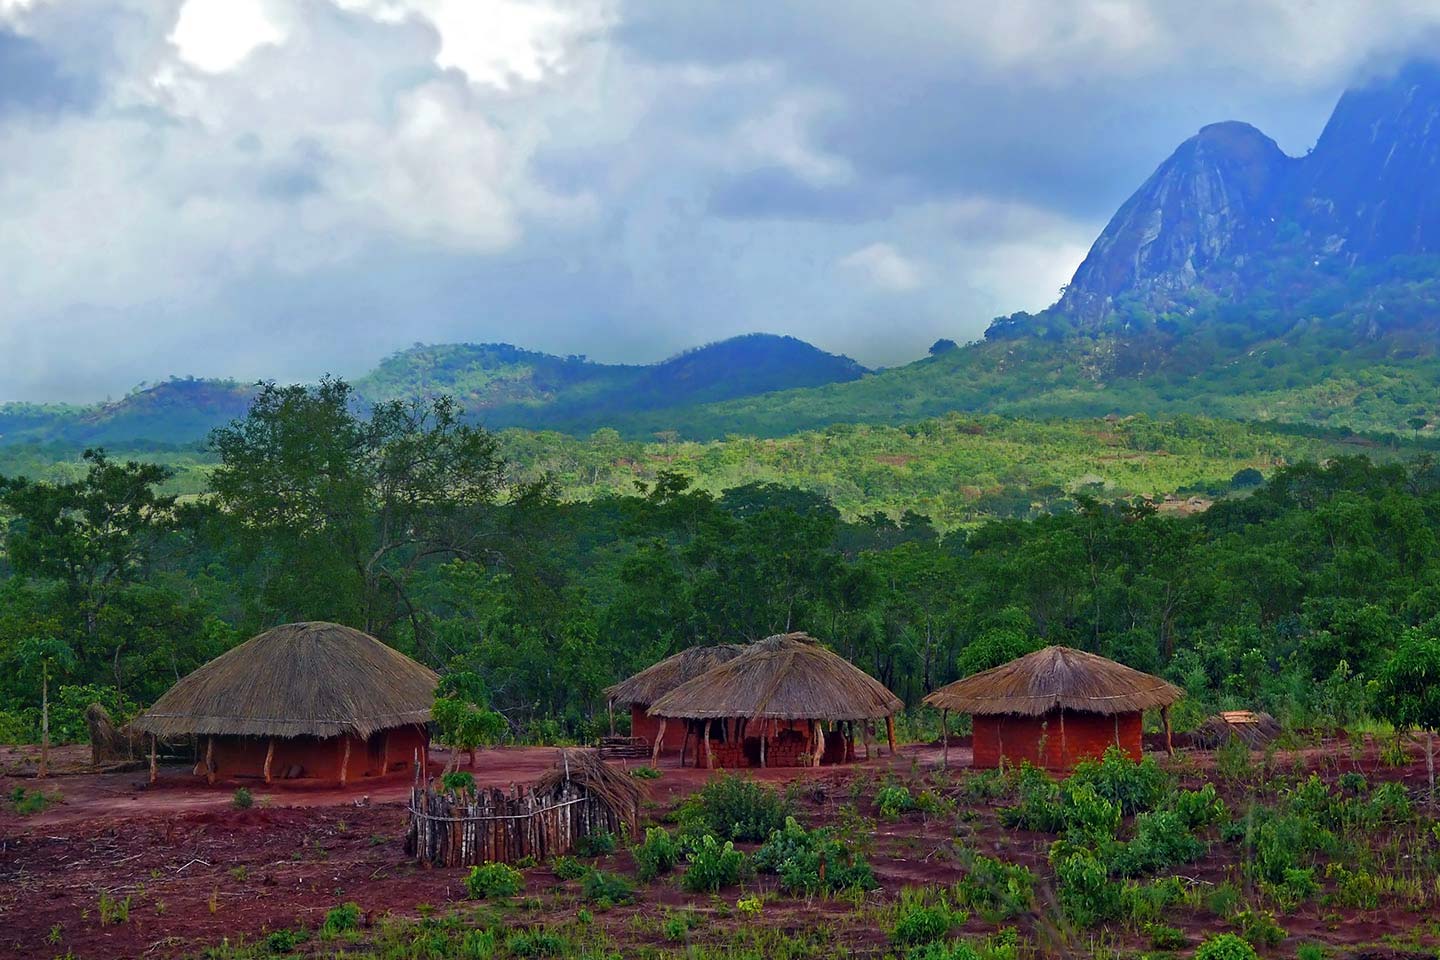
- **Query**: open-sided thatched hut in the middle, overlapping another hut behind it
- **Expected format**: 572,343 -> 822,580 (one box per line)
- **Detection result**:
649,633 -> 903,769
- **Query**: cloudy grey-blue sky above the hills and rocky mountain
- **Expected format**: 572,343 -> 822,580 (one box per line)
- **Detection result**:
0,0 -> 1440,400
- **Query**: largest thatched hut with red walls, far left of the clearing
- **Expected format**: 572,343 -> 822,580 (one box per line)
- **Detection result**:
131,622 -> 439,784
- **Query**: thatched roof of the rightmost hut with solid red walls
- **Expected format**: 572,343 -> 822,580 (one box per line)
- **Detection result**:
924,646 -> 1181,717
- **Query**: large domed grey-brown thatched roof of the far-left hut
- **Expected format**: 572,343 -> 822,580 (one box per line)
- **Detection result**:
131,622 -> 439,737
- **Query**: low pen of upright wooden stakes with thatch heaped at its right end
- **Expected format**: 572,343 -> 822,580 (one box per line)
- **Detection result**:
405,750 -> 639,866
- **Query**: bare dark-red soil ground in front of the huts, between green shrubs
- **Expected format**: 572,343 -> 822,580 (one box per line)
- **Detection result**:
0,744 -> 1434,960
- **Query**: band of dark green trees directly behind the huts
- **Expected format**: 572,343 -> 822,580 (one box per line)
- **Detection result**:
0,380 -> 1440,738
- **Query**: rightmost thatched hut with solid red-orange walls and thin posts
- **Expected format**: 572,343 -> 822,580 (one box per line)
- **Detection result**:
924,646 -> 1181,770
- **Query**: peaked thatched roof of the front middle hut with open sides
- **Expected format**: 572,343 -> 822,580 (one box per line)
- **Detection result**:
649,633 -> 904,720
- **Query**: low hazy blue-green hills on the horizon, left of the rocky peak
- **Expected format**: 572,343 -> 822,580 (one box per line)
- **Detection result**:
0,334 -> 868,445
